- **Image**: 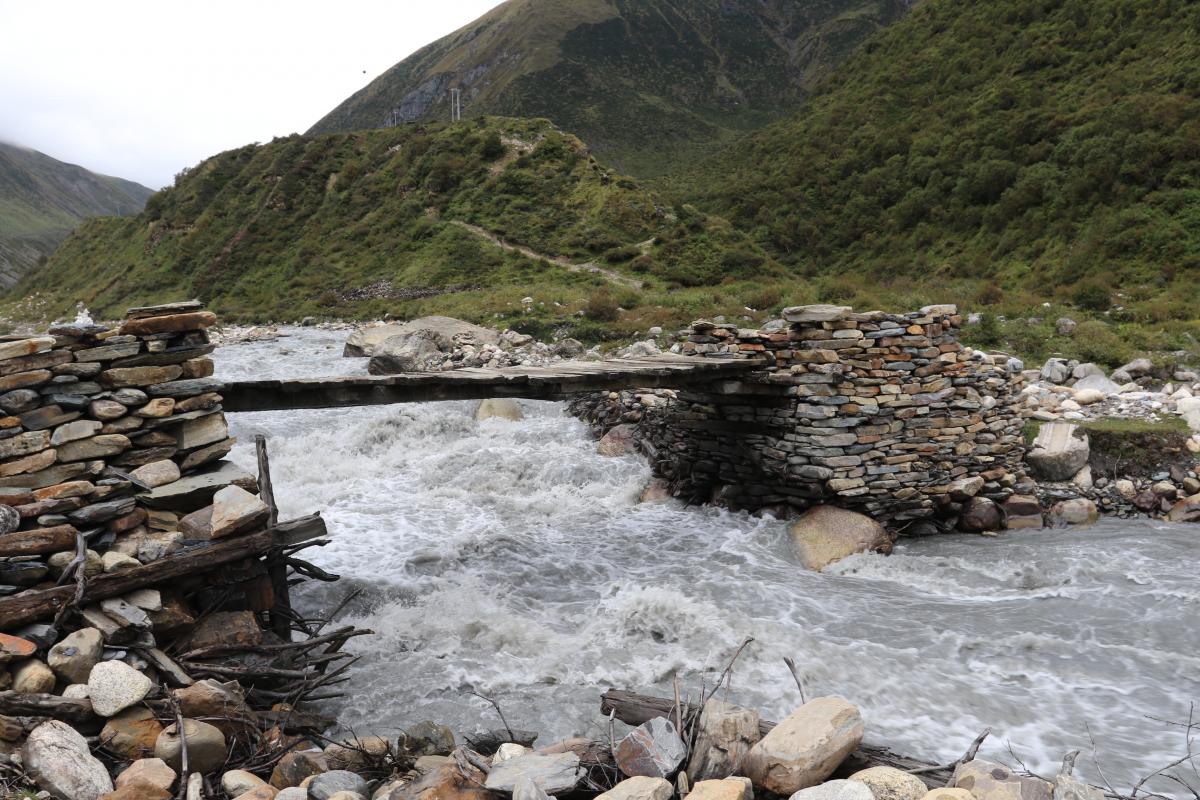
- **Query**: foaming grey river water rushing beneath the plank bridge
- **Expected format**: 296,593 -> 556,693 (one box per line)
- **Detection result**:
216,329 -> 1200,790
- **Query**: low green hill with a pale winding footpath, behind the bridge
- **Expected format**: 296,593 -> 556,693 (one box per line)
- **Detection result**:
18,118 -> 778,338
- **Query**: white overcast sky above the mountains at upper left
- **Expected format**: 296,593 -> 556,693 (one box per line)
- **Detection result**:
0,0 -> 499,188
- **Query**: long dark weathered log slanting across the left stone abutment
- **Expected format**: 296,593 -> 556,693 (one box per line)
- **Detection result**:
0,516 -> 326,628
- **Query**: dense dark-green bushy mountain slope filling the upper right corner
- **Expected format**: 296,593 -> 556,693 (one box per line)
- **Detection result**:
674,0 -> 1200,331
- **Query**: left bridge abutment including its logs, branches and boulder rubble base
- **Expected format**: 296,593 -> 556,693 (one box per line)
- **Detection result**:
0,301 -> 365,800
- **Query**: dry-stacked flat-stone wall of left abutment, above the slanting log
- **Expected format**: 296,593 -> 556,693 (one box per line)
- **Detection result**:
0,301 -> 243,595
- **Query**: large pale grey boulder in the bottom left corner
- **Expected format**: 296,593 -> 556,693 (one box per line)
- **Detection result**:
22,720 -> 114,800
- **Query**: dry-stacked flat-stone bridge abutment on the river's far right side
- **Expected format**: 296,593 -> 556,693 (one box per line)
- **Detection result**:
576,306 -> 1024,527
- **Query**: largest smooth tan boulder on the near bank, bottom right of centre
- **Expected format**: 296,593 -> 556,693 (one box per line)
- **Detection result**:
742,697 -> 863,795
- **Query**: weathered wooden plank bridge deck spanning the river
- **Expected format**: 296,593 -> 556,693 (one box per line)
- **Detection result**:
221,355 -> 763,411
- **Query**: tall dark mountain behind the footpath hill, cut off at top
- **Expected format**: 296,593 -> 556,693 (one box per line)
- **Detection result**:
312,0 -> 911,176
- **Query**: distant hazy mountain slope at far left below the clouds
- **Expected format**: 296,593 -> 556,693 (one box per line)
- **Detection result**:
0,142 -> 154,288
